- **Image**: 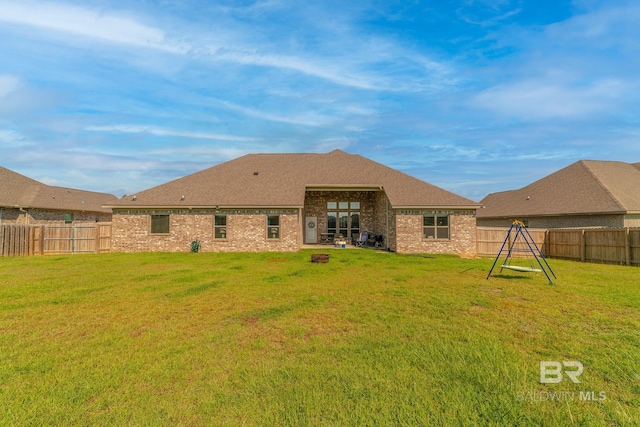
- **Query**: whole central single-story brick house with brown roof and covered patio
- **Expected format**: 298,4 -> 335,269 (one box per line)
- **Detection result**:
105,150 -> 479,254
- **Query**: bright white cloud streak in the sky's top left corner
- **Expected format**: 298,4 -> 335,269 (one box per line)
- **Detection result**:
0,1 -> 184,53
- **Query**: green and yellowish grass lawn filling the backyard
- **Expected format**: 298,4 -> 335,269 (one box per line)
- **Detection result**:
0,250 -> 640,426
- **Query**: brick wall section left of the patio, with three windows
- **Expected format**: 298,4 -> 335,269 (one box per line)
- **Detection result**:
112,209 -> 302,252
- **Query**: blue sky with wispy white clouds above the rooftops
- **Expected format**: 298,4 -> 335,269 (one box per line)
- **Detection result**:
0,0 -> 640,201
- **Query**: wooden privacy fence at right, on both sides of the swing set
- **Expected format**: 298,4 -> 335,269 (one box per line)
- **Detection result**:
477,227 -> 640,266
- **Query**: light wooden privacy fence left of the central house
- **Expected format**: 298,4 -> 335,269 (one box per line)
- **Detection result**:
0,223 -> 111,256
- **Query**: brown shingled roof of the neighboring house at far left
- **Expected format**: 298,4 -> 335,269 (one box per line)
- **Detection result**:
0,166 -> 118,213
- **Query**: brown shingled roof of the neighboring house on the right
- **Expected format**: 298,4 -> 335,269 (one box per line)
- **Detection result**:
477,160 -> 640,219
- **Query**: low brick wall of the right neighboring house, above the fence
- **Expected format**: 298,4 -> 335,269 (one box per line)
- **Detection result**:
478,215 -> 624,228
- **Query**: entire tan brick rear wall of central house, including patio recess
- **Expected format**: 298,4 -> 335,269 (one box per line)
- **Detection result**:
112,201 -> 476,255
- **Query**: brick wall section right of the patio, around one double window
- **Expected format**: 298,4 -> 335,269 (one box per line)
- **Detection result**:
395,210 -> 477,256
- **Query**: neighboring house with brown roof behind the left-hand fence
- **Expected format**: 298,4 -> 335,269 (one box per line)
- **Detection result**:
0,166 -> 118,225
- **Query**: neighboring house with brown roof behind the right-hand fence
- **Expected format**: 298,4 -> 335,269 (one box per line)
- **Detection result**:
478,160 -> 640,228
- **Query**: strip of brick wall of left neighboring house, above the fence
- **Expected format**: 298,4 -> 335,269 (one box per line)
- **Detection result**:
2,208 -> 111,225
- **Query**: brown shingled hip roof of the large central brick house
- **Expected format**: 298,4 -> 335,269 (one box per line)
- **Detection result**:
108,150 -> 479,209
